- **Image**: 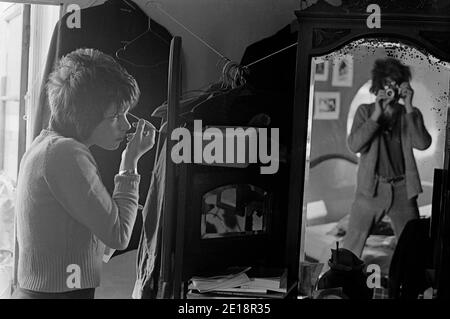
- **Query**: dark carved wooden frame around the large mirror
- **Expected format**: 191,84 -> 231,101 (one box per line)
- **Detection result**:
286,0 -> 450,296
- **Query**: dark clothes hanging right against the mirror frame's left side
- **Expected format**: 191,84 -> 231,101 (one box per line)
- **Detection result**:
240,23 -> 301,250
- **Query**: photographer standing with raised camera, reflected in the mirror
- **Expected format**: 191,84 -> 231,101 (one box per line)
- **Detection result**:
342,58 -> 431,256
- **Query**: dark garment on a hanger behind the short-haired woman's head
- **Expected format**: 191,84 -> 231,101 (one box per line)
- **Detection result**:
33,0 -> 172,255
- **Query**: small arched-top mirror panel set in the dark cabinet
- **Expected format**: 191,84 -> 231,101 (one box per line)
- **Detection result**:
201,184 -> 270,238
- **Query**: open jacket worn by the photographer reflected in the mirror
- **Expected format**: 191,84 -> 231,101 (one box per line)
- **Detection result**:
347,103 -> 431,198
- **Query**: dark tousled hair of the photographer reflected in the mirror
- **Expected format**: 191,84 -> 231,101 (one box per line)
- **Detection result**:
370,58 -> 411,94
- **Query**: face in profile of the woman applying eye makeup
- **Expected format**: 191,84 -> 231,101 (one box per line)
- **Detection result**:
88,105 -> 131,150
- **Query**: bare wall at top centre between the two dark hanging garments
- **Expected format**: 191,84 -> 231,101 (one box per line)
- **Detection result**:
135,0 -> 299,89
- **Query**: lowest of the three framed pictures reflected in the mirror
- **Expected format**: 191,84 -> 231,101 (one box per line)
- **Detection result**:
314,92 -> 341,120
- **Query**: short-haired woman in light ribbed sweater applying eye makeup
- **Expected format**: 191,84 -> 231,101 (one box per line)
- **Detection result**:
13,49 -> 155,298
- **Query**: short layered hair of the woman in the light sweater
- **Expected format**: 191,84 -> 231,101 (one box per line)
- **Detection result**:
46,49 -> 140,141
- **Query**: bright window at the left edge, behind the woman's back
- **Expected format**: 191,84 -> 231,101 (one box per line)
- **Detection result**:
0,2 -> 60,181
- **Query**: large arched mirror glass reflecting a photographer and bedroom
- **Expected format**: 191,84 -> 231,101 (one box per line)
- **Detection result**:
300,39 -> 450,277
